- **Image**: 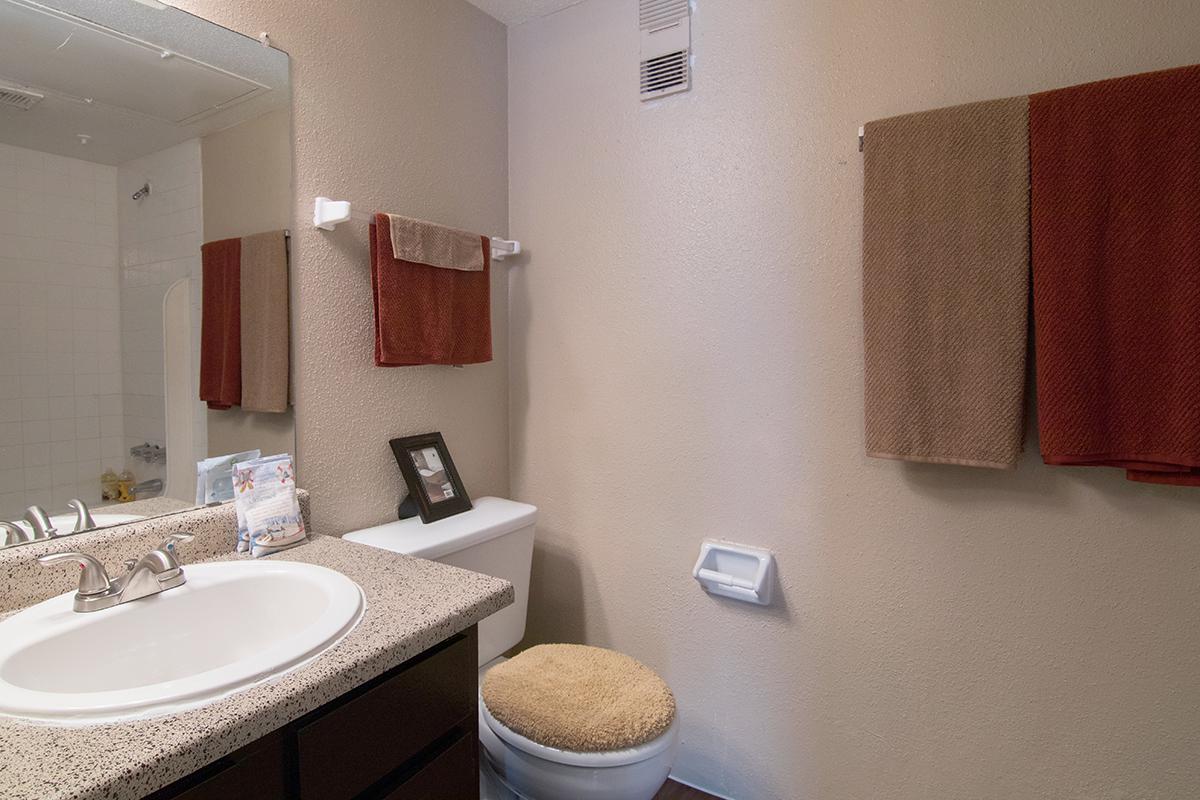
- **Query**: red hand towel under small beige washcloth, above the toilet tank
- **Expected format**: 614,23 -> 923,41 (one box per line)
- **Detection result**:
371,213 -> 492,367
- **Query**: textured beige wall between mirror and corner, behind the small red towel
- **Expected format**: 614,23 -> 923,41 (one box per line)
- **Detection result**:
173,0 -> 509,533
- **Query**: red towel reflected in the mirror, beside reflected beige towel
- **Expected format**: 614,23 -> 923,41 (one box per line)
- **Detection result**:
200,239 -> 241,409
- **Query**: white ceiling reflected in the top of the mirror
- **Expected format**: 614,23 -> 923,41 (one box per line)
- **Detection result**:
0,0 -> 289,164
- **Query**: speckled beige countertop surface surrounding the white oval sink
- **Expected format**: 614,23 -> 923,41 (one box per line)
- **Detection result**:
0,536 -> 514,800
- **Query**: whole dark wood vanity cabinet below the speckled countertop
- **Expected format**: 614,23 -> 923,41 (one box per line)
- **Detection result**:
150,627 -> 479,800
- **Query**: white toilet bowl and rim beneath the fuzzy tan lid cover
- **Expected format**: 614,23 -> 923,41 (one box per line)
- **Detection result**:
479,658 -> 679,800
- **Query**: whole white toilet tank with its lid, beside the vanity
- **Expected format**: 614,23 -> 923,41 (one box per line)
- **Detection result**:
343,498 -> 538,666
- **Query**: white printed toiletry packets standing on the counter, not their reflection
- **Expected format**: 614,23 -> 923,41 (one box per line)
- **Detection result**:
233,453 -> 306,558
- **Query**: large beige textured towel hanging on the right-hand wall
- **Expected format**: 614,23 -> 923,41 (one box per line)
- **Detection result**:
863,97 -> 1030,468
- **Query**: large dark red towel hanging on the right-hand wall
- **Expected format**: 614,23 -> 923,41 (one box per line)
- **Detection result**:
1030,67 -> 1200,485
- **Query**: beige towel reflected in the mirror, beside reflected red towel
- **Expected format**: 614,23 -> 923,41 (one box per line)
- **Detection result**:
241,230 -> 290,411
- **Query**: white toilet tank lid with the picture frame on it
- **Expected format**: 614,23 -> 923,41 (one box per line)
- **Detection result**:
342,498 -> 538,559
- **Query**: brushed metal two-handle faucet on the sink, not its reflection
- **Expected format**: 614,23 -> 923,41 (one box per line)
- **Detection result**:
37,533 -> 192,612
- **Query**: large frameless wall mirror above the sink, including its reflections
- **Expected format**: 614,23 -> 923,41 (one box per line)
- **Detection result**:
0,0 -> 295,546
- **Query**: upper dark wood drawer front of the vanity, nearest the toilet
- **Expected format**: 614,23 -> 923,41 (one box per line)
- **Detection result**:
296,627 -> 478,800
